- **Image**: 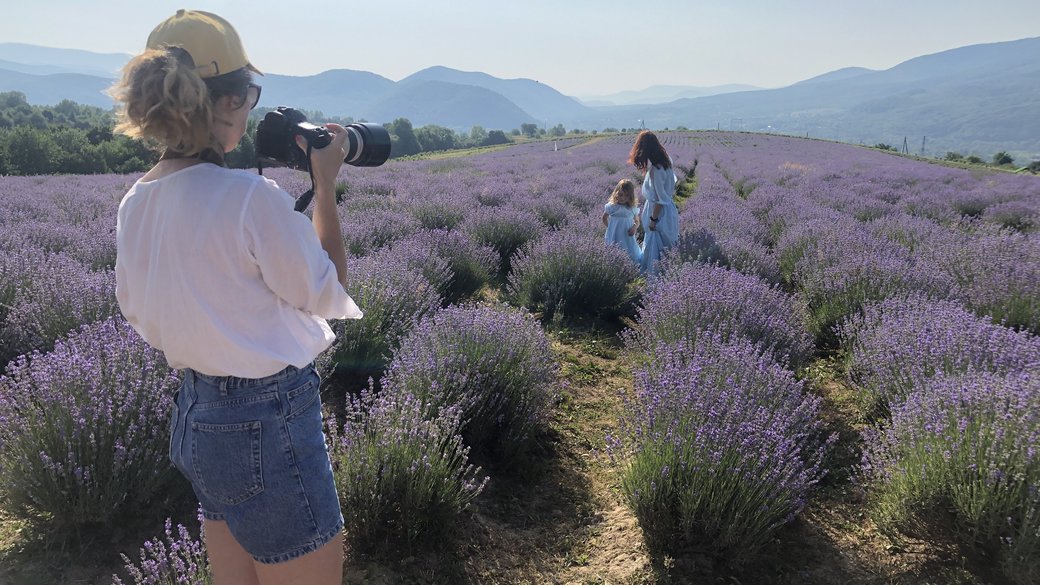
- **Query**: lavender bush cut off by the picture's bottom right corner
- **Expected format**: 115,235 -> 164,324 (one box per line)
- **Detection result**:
863,371 -> 1040,585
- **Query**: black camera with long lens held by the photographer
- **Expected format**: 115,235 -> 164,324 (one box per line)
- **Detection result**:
256,106 -> 390,171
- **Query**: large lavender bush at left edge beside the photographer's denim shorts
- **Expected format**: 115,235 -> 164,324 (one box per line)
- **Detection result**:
0,317 -> 179,529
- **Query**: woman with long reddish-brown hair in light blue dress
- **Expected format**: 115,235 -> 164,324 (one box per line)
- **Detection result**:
628,130 -> 679,275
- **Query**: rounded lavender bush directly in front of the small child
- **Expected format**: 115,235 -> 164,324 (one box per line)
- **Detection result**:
506,230 -> 639,319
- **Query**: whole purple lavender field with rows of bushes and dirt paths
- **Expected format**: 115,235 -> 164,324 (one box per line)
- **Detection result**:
0,132 -> 1040,585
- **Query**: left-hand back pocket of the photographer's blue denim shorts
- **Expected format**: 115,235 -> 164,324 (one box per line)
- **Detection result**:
191,421 -> 263,505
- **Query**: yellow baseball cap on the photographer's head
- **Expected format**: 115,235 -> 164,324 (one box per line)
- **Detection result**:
146,9 -> 263,77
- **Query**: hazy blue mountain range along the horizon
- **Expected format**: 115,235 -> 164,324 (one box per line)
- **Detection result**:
0,37 -> 1040,158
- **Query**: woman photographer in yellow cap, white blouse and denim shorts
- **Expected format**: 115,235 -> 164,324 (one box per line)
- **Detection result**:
112,10 -> 361,585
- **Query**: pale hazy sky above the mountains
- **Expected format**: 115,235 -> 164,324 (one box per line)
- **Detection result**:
0,0 -> 1040,96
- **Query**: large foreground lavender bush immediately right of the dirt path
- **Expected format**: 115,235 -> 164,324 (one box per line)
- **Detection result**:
610,334 -> 829,559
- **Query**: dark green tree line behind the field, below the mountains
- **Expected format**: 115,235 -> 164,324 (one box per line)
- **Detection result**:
0,92 -> 607,175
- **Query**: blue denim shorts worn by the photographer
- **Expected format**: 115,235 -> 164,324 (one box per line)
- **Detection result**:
170,365 -> 343,563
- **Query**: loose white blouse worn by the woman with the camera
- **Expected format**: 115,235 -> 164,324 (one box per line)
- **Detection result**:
115,163 -> 362,378
